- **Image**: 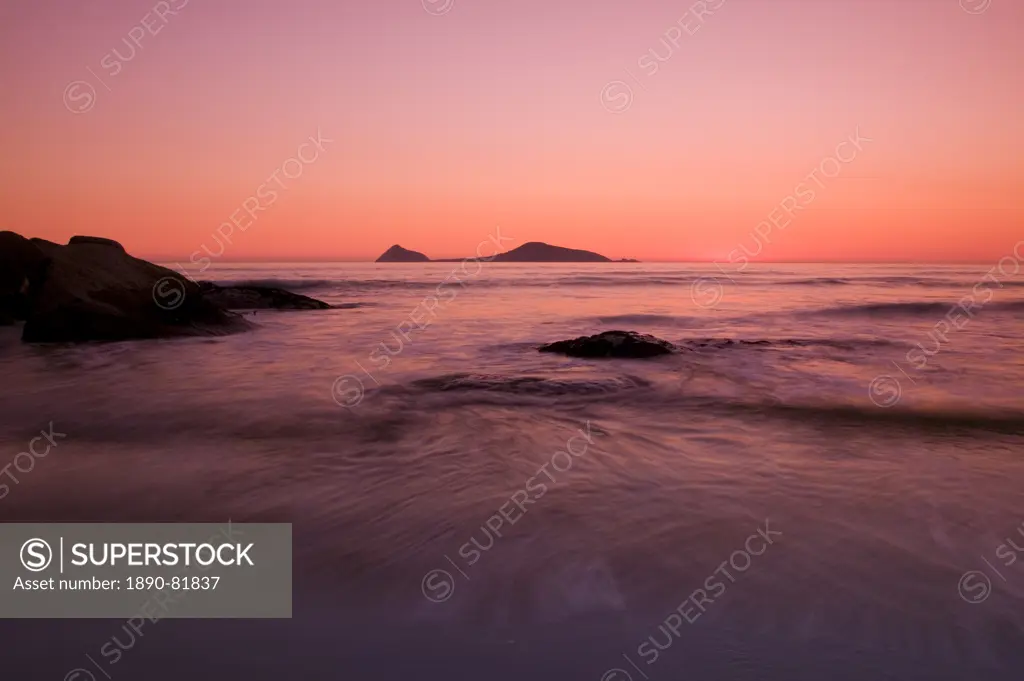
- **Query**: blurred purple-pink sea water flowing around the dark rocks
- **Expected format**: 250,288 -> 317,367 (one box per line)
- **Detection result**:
0,258 -> 1024,681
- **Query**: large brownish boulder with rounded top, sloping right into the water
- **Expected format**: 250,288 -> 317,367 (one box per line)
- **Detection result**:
22,237 -> 252,342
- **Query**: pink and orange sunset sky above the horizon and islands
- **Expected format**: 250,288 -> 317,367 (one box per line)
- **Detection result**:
0,0 -> 1024,262
